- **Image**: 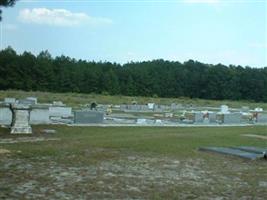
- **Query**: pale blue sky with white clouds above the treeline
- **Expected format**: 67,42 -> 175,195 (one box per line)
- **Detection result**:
0,0 -> 267,68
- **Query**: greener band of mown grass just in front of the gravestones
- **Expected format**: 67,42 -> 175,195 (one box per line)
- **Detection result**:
0,126 -> 267,158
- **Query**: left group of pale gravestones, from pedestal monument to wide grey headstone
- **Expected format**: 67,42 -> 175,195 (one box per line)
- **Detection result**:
0,97 -> 104,134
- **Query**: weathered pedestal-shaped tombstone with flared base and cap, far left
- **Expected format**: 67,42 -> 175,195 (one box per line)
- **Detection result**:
11,104 -> 32,134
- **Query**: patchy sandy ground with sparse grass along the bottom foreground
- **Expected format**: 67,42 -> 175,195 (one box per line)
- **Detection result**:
0,149 -> 267,200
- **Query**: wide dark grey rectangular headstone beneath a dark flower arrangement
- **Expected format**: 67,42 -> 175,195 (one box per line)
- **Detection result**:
74,111 -> 104,124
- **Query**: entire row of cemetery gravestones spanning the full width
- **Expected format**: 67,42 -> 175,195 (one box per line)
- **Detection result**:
0,97 -> 267,133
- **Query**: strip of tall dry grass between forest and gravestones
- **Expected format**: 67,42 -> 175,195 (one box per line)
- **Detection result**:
0,90 -> 267,110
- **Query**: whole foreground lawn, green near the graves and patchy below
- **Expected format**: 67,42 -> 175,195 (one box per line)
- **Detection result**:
0,126 -> 267,199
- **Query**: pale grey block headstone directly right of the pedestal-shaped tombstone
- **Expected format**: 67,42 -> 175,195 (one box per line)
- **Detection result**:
30,105 -> 50,124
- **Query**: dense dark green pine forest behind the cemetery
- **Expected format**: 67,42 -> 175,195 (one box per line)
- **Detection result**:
0,47 -> 267,102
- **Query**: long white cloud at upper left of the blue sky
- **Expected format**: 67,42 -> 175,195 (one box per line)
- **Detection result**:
18,8 -> 112,27
